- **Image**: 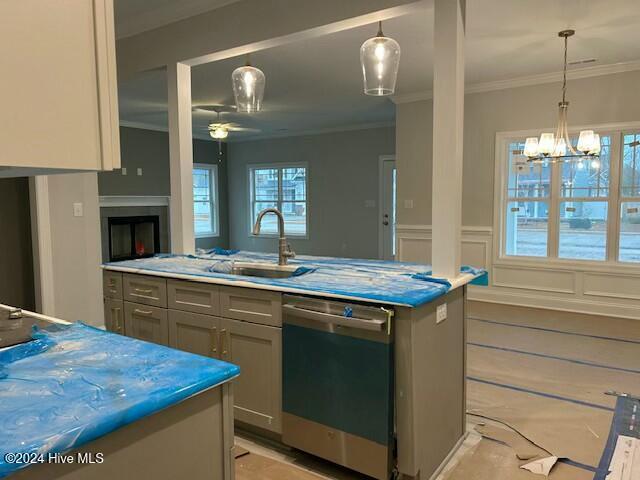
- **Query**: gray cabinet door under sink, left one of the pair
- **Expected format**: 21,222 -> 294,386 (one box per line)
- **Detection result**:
169,310 -> 220,358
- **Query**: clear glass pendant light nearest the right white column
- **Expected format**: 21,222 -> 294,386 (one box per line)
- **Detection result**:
360,22 -> 400,96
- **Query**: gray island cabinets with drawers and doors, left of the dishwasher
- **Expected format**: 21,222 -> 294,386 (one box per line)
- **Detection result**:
104,270 -> 282,434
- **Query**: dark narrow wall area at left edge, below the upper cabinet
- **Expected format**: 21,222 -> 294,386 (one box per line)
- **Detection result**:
0,178 -> 35,310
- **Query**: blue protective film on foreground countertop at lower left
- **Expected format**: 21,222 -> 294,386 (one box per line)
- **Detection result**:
0,323 -> 240,478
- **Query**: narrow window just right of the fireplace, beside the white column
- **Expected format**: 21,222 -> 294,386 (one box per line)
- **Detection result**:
193,164 -> 219,237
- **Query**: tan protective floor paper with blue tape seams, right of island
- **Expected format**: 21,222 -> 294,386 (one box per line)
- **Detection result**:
445,303 -> 640,480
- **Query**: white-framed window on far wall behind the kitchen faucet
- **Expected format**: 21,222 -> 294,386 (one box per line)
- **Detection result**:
249,165 -> 308,236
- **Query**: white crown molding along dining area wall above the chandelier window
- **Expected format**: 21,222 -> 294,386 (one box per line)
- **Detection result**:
391,60 -> 640,104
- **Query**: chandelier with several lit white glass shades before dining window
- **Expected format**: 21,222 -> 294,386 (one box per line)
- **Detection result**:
524,30 -> 601,168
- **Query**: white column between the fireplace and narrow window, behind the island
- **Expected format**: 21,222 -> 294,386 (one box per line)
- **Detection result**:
167,63 -> 195,254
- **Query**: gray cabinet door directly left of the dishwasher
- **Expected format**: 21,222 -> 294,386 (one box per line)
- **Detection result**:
219,318 -> 282,433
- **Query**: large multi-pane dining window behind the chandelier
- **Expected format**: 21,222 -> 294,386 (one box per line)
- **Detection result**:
500,129 -> 640,263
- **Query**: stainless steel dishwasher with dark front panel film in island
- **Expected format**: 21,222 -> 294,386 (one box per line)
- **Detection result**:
282,295 -> 394,480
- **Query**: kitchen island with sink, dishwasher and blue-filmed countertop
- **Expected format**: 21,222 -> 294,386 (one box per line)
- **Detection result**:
103,250 -> 485,479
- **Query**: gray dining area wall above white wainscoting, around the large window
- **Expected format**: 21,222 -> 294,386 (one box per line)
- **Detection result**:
396,71 -> 640,226
